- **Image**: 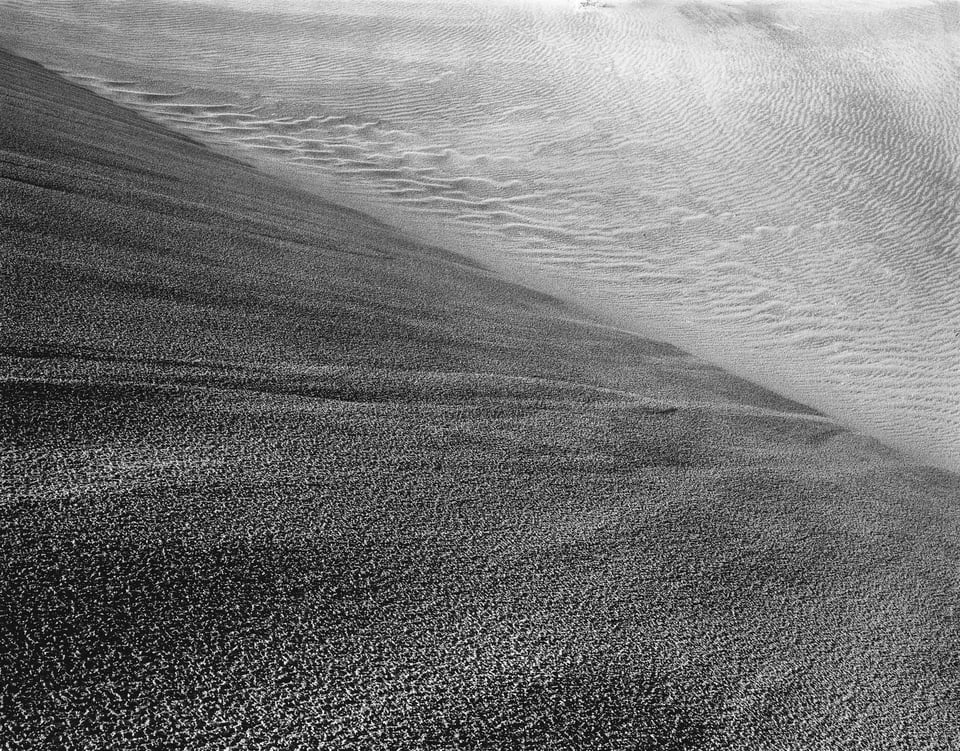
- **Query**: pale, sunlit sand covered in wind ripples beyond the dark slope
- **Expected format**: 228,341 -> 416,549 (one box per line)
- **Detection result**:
0,0 -> 960,467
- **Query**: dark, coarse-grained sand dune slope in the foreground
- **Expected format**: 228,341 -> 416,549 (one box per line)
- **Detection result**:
0,50 -> 960,749
